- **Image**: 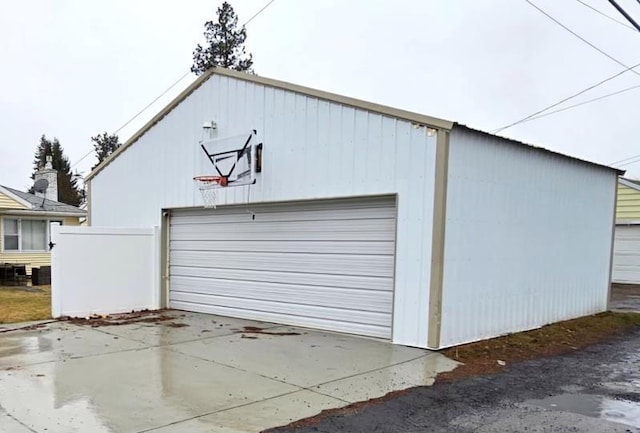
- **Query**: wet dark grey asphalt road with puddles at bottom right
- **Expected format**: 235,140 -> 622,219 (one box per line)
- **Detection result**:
270,330 -> 640,433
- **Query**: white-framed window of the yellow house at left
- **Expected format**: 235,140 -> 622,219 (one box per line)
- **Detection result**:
3,218 -> 48,251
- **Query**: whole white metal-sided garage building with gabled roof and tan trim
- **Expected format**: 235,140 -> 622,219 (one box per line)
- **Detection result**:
82,69 -> 619,348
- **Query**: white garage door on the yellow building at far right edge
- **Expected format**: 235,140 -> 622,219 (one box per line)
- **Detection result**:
612,225 -> 640,284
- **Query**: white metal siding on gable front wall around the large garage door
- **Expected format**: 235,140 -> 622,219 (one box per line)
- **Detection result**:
91,75 -> 436,347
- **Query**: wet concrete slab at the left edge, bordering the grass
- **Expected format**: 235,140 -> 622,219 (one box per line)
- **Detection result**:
0,322 -> 146,369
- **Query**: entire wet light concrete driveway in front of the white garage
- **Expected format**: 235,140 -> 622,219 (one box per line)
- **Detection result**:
0,311 -> 455,433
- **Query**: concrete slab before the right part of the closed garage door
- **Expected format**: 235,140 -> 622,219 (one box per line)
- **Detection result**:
171,326 -> 429,388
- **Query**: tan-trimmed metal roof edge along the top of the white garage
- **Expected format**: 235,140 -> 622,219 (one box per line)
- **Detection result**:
86,68 -> 624,181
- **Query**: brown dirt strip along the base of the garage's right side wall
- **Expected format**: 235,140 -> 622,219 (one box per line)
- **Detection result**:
436,312 -> 640,382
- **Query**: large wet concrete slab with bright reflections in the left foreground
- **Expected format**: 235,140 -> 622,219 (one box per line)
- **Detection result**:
0,348 -> 299,433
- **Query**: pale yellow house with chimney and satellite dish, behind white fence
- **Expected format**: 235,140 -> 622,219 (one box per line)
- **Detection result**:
0,159 -> 86,275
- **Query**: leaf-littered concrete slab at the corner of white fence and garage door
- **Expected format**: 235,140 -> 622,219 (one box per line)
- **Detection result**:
98,311 -> 279,346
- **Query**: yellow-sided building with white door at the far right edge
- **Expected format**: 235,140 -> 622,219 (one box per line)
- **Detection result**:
612,178 -> 640,284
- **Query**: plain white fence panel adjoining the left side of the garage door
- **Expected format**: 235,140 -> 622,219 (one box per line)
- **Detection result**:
51,226 -> 160,317
